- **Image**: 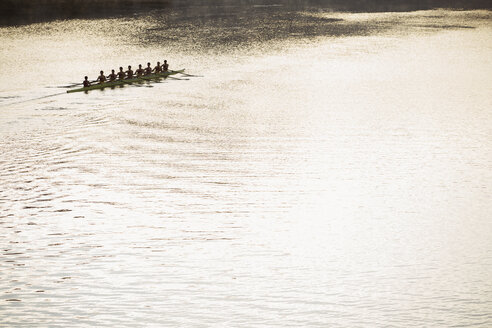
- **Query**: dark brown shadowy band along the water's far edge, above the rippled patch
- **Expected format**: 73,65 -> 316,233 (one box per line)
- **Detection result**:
0,0 -> 492,26
